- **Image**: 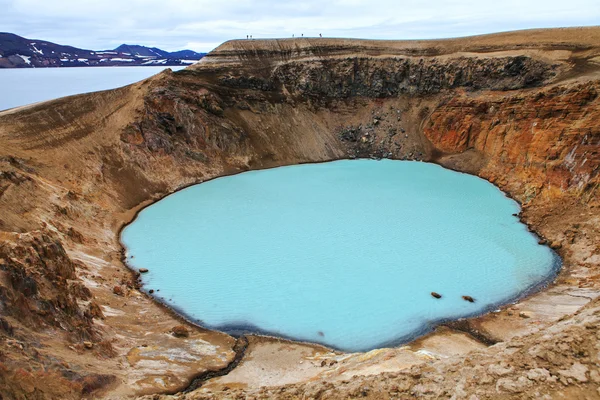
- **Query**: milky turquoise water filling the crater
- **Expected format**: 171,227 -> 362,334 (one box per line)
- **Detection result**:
122,160 -> 558,351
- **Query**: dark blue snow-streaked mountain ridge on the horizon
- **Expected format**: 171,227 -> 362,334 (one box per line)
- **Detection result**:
0,32 -> 206,68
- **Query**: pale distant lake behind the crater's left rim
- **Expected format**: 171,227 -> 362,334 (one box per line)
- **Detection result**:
0,67 -> 185,110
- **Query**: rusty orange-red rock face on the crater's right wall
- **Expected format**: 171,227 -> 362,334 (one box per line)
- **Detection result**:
423,82 -> 600,200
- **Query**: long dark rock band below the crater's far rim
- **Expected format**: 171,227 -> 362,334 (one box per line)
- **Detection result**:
274,56 -> 556,101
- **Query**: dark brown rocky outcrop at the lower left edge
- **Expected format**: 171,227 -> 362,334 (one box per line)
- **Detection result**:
0,231 -> 116,399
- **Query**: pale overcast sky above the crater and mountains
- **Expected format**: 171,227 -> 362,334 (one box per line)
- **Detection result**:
0,0 -> 600,51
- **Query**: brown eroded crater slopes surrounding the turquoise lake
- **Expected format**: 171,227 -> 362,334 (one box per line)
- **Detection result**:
0,28 -> 600,398
